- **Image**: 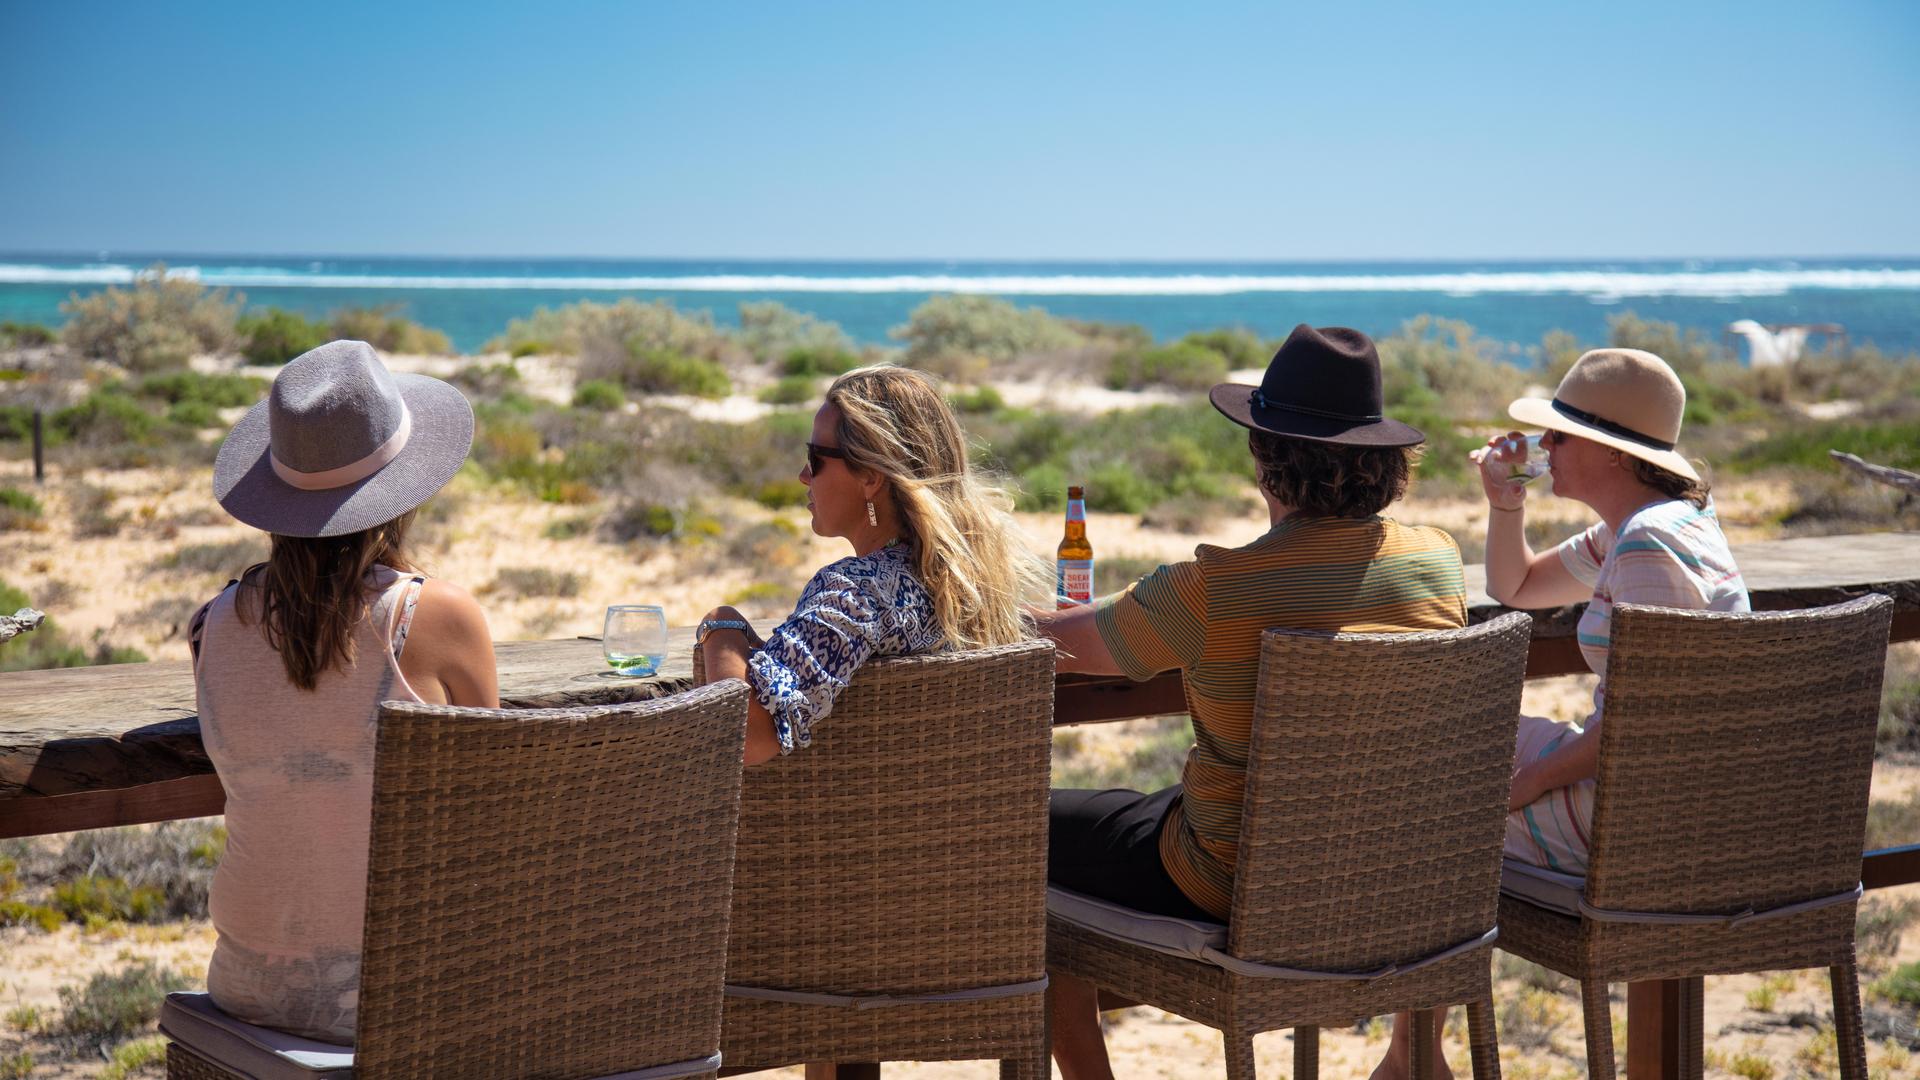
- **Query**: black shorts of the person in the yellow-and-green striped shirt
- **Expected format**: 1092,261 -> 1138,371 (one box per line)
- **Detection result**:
1046,784 -> 1219,922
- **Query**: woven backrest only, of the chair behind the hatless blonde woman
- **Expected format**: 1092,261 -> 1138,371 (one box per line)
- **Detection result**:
728,642 -> 1054,999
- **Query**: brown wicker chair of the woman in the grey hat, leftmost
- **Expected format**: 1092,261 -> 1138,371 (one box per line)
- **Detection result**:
161,680 -> 747,1080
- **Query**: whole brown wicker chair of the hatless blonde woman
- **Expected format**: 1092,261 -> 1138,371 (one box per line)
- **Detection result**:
695,642 -> 1054,1080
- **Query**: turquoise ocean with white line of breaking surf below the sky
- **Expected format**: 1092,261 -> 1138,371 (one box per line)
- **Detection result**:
0,254 -> 1920,359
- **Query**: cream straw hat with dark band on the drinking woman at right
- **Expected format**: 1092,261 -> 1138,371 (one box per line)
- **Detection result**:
1507,348 -> 1699,480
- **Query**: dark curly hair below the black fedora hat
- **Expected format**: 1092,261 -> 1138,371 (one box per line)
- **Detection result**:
1246,430 -> 1423,517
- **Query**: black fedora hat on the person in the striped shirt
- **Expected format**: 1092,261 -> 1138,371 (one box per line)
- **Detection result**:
1210,323 -> 1427,446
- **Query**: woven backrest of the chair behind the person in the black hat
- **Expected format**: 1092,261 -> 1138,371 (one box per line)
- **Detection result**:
1227,613 -> 1532,972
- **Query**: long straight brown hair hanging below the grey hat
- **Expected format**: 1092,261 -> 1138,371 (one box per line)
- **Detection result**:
234,509 -> 415,690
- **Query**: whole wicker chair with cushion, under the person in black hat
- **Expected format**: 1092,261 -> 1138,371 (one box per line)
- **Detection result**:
1046,613 -> 1532,1080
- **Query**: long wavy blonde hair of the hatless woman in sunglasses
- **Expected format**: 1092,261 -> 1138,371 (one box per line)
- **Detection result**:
828,365 -> 1054,650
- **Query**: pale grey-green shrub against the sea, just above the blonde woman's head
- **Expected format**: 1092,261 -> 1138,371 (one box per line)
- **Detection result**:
891,296 -> 1087,382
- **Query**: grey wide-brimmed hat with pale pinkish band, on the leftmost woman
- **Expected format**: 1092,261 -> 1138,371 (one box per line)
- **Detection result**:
213,340 -> 474,536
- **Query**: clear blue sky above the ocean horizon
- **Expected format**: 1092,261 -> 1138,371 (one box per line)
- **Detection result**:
0,0 -> 1920,259
